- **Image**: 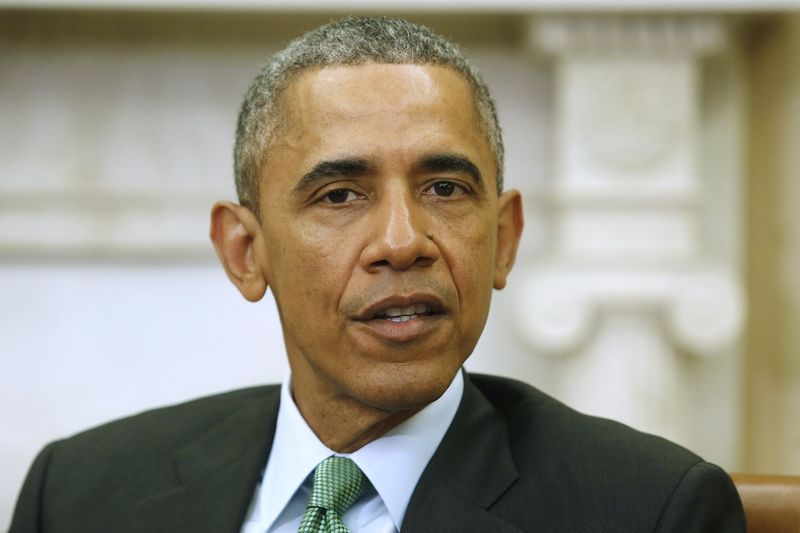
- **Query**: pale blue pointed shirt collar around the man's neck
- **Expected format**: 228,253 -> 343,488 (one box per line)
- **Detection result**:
257,371 -> 464,531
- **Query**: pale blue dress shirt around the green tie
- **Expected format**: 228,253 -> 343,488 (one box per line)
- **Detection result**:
242,372 -> 464,533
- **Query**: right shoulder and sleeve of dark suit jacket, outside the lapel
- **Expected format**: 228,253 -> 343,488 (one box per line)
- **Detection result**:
462,375 -> 744,531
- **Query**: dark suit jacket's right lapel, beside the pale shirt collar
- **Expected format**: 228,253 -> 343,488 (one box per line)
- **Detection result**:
403,373 -> 521,532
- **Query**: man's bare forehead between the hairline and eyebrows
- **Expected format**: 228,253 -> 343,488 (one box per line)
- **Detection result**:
270,64 -> 494,174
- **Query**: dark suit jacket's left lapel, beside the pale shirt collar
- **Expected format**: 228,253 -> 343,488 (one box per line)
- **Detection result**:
133,388 -> 280,533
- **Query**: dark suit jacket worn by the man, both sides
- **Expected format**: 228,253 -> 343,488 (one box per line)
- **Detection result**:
10,375 -> 744,533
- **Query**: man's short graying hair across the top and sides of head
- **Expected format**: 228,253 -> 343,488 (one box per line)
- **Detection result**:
234,17 -> 503,216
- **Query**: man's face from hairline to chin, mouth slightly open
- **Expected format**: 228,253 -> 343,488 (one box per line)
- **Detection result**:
255,64 -> 521,411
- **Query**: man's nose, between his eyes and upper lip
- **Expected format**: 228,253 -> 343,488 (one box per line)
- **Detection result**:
362,186 -> 439,271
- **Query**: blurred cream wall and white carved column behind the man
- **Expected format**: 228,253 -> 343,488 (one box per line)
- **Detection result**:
0,0 -> 800,524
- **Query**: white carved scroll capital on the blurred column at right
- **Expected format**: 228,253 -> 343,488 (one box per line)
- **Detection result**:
514,265 -> 744,356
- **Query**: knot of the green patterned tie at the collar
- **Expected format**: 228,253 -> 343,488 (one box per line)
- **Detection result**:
308,456 -> 370,516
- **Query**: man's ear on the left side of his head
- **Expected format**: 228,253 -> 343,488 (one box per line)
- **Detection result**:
209,202 -> 267,302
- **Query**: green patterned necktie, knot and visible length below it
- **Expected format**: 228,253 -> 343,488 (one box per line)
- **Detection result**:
297,456 -> 370,533
